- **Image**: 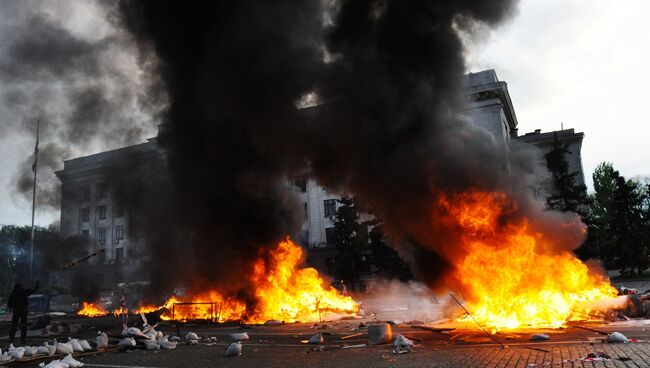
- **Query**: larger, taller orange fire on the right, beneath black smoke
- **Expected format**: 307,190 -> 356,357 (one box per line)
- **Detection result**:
434,191 -> 616,329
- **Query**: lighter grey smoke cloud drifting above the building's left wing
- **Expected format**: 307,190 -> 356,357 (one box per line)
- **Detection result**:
0,0 -> 164,211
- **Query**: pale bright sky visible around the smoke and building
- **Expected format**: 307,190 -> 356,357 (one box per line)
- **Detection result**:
0,0 -> 650,225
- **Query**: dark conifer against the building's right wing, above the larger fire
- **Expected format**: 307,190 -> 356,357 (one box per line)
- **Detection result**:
544,133 -> 587,217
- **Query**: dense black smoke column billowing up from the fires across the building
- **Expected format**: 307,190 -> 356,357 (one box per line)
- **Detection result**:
120,0 -> 540,302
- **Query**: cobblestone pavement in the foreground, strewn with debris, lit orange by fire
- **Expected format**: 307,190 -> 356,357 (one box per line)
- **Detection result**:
3,321 -> 650,368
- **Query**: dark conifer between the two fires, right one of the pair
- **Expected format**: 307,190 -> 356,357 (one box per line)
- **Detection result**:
369,225 -> 413,281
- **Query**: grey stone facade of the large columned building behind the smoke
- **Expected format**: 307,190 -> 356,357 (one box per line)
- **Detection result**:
57,70 -> 584,281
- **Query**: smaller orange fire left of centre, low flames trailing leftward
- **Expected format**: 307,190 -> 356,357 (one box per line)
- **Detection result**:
79,238 -> 359,323
